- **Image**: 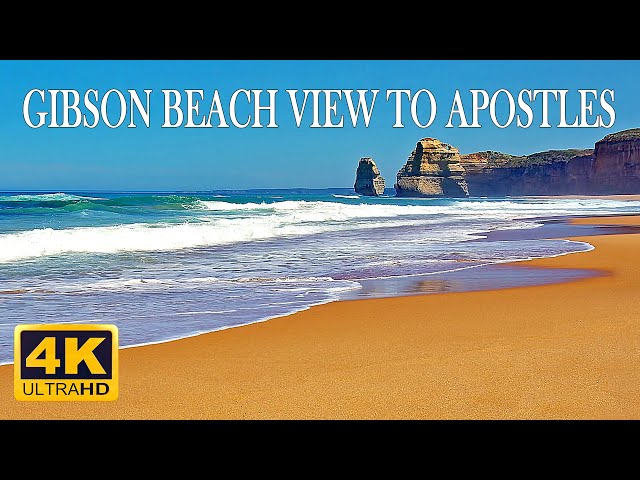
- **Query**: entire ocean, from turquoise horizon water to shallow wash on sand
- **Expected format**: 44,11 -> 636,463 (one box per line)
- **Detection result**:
0,188 -> 640,364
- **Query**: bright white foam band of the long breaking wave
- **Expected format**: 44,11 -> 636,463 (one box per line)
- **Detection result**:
0,199 -> 640,262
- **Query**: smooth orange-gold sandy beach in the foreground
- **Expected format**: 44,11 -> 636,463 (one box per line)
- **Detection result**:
0,216 -> 640,419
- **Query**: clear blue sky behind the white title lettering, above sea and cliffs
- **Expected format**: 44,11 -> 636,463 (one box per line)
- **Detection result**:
0,60 -> 640,191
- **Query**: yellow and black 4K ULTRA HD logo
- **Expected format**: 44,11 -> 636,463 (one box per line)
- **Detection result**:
14,324 -> 118,402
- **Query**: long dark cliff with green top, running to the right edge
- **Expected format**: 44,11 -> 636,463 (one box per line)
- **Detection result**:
461,129 -> 640,196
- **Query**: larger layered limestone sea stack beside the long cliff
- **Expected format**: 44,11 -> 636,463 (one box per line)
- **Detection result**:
394,138 -> 469,197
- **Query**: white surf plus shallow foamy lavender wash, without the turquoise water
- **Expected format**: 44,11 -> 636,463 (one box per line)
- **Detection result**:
0,193 -> 640,364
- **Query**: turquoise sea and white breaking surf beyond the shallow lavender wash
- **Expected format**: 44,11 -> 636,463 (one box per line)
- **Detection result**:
0,193 -> 636,262
